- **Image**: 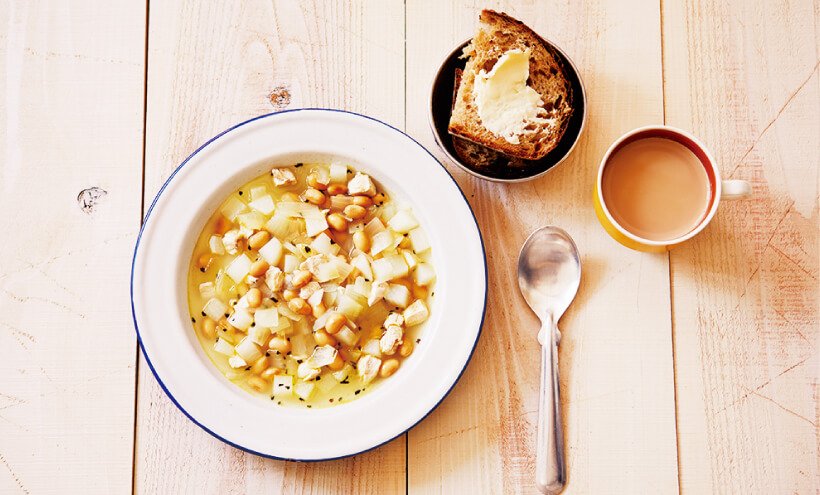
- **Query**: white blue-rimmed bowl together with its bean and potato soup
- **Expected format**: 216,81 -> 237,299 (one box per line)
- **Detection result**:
131,109 -> 486,461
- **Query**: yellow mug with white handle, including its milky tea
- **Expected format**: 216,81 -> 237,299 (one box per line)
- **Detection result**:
595,125 -> 752,252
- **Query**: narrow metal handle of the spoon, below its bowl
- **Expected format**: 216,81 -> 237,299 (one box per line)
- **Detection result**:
535,315 -> 567,495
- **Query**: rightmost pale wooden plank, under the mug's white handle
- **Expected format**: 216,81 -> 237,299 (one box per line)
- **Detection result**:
663,0 -> 820,493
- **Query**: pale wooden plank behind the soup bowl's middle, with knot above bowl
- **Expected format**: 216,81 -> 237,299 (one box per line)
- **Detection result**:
135,0 -> 405,493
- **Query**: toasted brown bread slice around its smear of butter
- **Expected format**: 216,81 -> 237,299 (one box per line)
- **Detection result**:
448,10 -> 572,160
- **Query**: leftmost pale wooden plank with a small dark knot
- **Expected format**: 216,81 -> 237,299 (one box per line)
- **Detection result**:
0,0 -> 145,494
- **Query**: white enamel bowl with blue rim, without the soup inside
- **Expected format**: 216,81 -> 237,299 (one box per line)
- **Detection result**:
131,109 -> 487,461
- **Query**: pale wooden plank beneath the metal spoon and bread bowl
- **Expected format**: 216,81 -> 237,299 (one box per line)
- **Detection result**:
407,1 -> 678,494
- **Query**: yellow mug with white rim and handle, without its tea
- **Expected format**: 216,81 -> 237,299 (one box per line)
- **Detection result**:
595,125 -> 752,253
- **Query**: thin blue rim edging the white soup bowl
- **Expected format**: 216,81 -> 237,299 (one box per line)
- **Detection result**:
130,108 -> 488,462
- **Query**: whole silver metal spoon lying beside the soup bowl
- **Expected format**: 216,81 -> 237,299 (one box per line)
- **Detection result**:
518,226 -> 581,494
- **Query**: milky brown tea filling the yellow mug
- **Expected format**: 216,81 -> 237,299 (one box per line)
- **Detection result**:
601,137 -> 711,241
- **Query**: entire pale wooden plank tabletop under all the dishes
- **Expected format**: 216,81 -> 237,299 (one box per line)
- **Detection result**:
0,0 -> 820,494
